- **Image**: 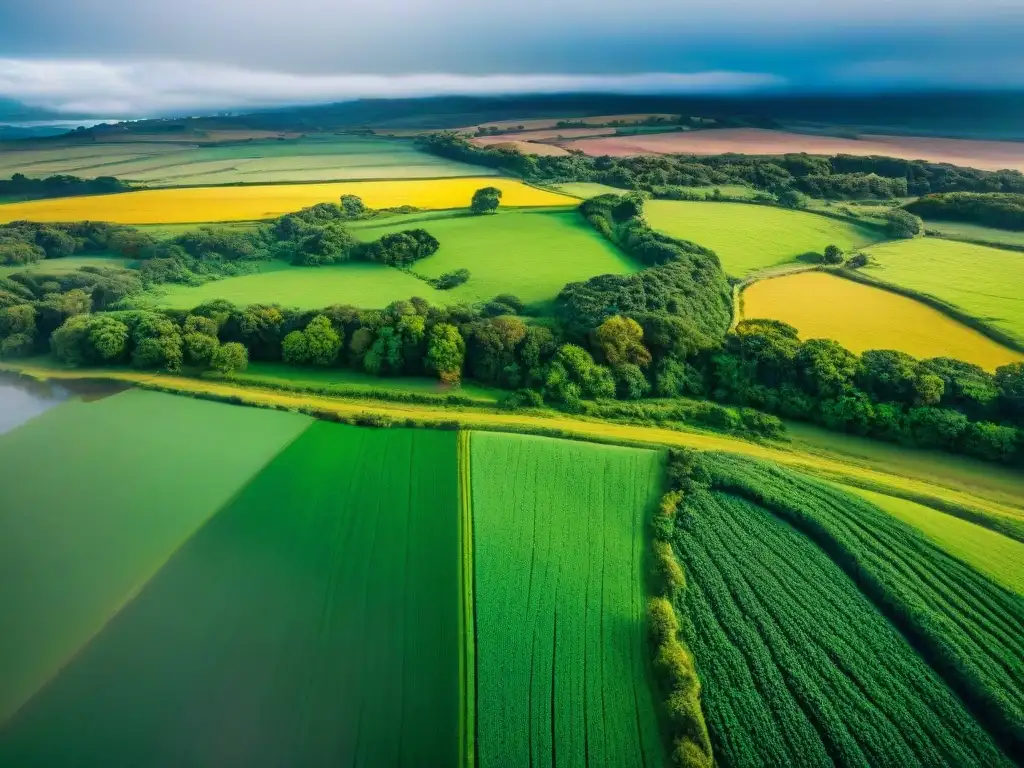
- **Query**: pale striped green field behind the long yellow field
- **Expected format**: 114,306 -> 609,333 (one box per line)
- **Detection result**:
0,135 -> 495,186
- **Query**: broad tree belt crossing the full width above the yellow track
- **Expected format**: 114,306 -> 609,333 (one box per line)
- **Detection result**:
0,195 -> 1024,462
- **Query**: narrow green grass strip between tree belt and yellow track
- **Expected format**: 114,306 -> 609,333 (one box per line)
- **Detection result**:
237,362 -> 508,404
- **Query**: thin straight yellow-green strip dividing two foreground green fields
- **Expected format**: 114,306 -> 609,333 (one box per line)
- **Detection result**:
458,429 -> 478,768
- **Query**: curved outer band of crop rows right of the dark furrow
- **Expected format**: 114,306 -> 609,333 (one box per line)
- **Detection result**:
698,456 -> 1024,765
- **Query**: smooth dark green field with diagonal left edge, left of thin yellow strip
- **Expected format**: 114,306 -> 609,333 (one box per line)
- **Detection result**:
0,423 -> 460,766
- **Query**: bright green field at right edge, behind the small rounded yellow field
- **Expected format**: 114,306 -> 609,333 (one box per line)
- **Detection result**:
863,238 -> 1024,344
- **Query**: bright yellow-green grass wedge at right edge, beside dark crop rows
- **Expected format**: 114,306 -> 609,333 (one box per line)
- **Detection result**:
844,487 -> 1024,595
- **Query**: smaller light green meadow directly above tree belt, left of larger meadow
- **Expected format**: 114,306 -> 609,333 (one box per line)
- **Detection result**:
143,261 -> 447,309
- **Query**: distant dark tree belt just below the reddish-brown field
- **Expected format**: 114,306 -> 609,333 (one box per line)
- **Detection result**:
420,133 -> 1024,199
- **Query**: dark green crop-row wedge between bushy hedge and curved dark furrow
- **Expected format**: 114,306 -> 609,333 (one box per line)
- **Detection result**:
675,489 -> 1011,768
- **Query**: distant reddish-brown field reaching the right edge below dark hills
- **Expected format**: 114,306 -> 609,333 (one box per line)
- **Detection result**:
562,128 -> 1024,171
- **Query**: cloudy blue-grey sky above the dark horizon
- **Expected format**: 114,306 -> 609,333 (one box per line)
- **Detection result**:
0,0 -> 1024,117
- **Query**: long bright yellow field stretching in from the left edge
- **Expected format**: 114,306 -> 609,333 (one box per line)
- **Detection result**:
0,178 -> 578,224
